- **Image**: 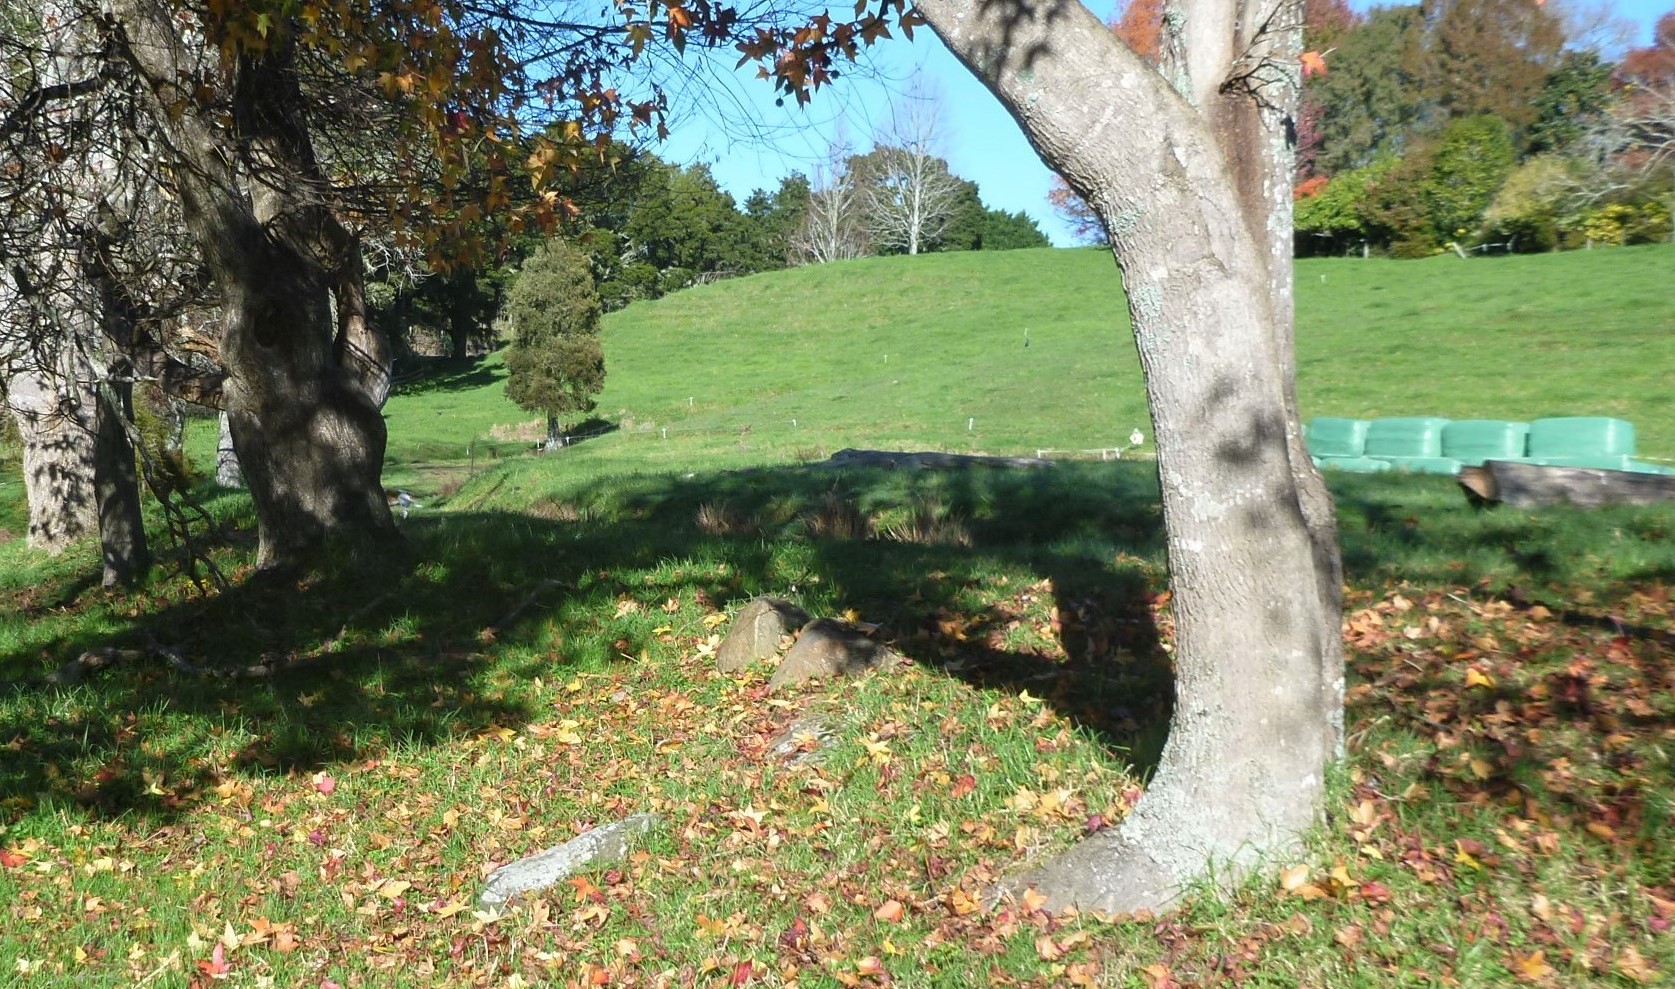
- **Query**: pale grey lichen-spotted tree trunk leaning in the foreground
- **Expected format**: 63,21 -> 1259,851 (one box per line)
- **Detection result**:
918,0 -> 1340,912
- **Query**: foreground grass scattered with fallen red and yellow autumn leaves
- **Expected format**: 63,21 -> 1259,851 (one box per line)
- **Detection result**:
0,466 -> 1675,987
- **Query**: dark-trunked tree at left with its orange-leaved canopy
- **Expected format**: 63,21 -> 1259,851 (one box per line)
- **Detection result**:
0,0 -> 713,567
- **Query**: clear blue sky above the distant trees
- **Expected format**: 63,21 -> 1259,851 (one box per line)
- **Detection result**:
655,0 -> 1675,245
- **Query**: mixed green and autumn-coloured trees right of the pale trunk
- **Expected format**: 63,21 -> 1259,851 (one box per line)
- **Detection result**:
1050,0 -> 1675,258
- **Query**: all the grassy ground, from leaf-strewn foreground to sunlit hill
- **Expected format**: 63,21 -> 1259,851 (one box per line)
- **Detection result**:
0,248 -> 1675,989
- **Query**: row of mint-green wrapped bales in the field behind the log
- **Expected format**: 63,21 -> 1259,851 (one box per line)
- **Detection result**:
1305,416 -> 1675,474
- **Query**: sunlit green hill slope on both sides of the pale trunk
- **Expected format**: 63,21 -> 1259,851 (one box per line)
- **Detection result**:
376,246 -> 1675,502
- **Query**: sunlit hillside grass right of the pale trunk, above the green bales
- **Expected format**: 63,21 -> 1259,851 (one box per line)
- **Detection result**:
1296,245 -> 1675,459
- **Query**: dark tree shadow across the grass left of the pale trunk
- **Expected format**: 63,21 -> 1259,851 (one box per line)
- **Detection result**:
0,464 -> 1171,820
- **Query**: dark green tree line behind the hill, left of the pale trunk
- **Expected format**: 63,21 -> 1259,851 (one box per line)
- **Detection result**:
367,134 -> 1050,357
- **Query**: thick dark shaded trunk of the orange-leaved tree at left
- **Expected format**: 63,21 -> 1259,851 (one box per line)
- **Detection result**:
109,0 -> 395,568
